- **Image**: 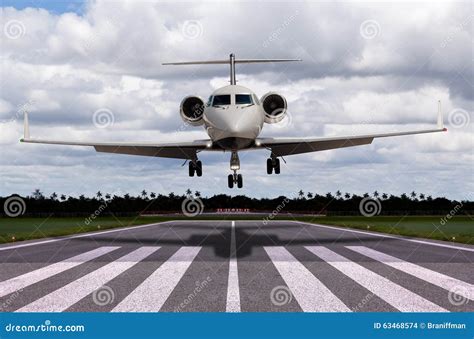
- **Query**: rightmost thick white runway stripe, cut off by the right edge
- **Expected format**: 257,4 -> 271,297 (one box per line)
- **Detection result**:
346,246 -> 474,300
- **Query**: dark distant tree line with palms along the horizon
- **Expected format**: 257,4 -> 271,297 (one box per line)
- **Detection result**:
0,189 -> 474,217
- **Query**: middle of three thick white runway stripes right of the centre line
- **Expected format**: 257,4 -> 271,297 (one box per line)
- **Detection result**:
306,246 -> 448,312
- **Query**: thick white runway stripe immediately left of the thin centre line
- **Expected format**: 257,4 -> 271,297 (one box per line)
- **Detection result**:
112,247 -> 201,312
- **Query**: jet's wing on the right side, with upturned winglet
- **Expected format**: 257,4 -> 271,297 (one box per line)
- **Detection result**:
255,105 -> 447,157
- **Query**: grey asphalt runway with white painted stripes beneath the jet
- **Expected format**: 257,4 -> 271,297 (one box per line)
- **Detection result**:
0,220 -> 474,312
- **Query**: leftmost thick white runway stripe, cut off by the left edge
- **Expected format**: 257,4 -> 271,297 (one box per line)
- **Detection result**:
0,246 -> 119,297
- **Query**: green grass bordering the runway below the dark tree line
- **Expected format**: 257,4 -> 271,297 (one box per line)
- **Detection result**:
0,215 -> 474,244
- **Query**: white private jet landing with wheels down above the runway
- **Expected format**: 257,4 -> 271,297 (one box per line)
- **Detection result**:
20,54 -> 447,188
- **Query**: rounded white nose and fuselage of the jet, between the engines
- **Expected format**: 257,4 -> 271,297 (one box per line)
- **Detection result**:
203,85 -> 265,151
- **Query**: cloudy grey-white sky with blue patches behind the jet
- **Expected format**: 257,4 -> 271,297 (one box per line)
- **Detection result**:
0,0 -> 474,200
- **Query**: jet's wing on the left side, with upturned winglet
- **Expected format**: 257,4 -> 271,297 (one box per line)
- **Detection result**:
20,113 -> 212,160
